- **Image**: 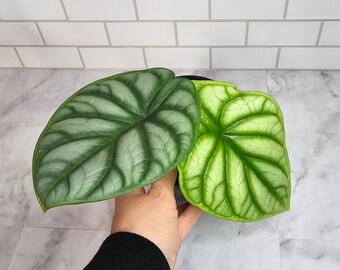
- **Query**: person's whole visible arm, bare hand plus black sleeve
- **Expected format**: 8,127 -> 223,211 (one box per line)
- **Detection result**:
85,170 -> 200,270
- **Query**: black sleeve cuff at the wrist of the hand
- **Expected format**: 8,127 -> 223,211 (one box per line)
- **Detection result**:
84,232 -> 170,270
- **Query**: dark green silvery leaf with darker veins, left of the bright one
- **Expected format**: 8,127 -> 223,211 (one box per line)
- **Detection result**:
33,69 -> 200,211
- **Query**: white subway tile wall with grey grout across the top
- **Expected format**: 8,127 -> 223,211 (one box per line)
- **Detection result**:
0,0 -> 340,70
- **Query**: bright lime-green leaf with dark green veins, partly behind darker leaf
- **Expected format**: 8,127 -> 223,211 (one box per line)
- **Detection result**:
179,81 -> 290,222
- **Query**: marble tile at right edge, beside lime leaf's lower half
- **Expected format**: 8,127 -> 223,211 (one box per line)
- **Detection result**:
280,134 -> 340,240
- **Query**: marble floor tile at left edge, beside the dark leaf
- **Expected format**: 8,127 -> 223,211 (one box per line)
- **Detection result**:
0,126 -> 41,269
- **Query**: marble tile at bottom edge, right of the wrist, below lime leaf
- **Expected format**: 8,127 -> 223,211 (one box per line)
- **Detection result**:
175,233 -> 281,270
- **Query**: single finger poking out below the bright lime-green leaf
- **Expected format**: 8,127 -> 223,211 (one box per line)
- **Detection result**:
178,205 -> 201,241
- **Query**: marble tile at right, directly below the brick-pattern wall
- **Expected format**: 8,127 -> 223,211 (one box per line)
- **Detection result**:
268,71 -> 340,133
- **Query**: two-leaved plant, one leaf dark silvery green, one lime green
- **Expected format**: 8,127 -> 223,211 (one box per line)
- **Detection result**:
33,68 -> 290,222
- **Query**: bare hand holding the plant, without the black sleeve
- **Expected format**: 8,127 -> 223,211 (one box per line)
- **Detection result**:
111,169 -> 201,269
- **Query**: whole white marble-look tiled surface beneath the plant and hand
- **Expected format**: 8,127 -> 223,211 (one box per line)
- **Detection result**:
0,69 -> 340,270
